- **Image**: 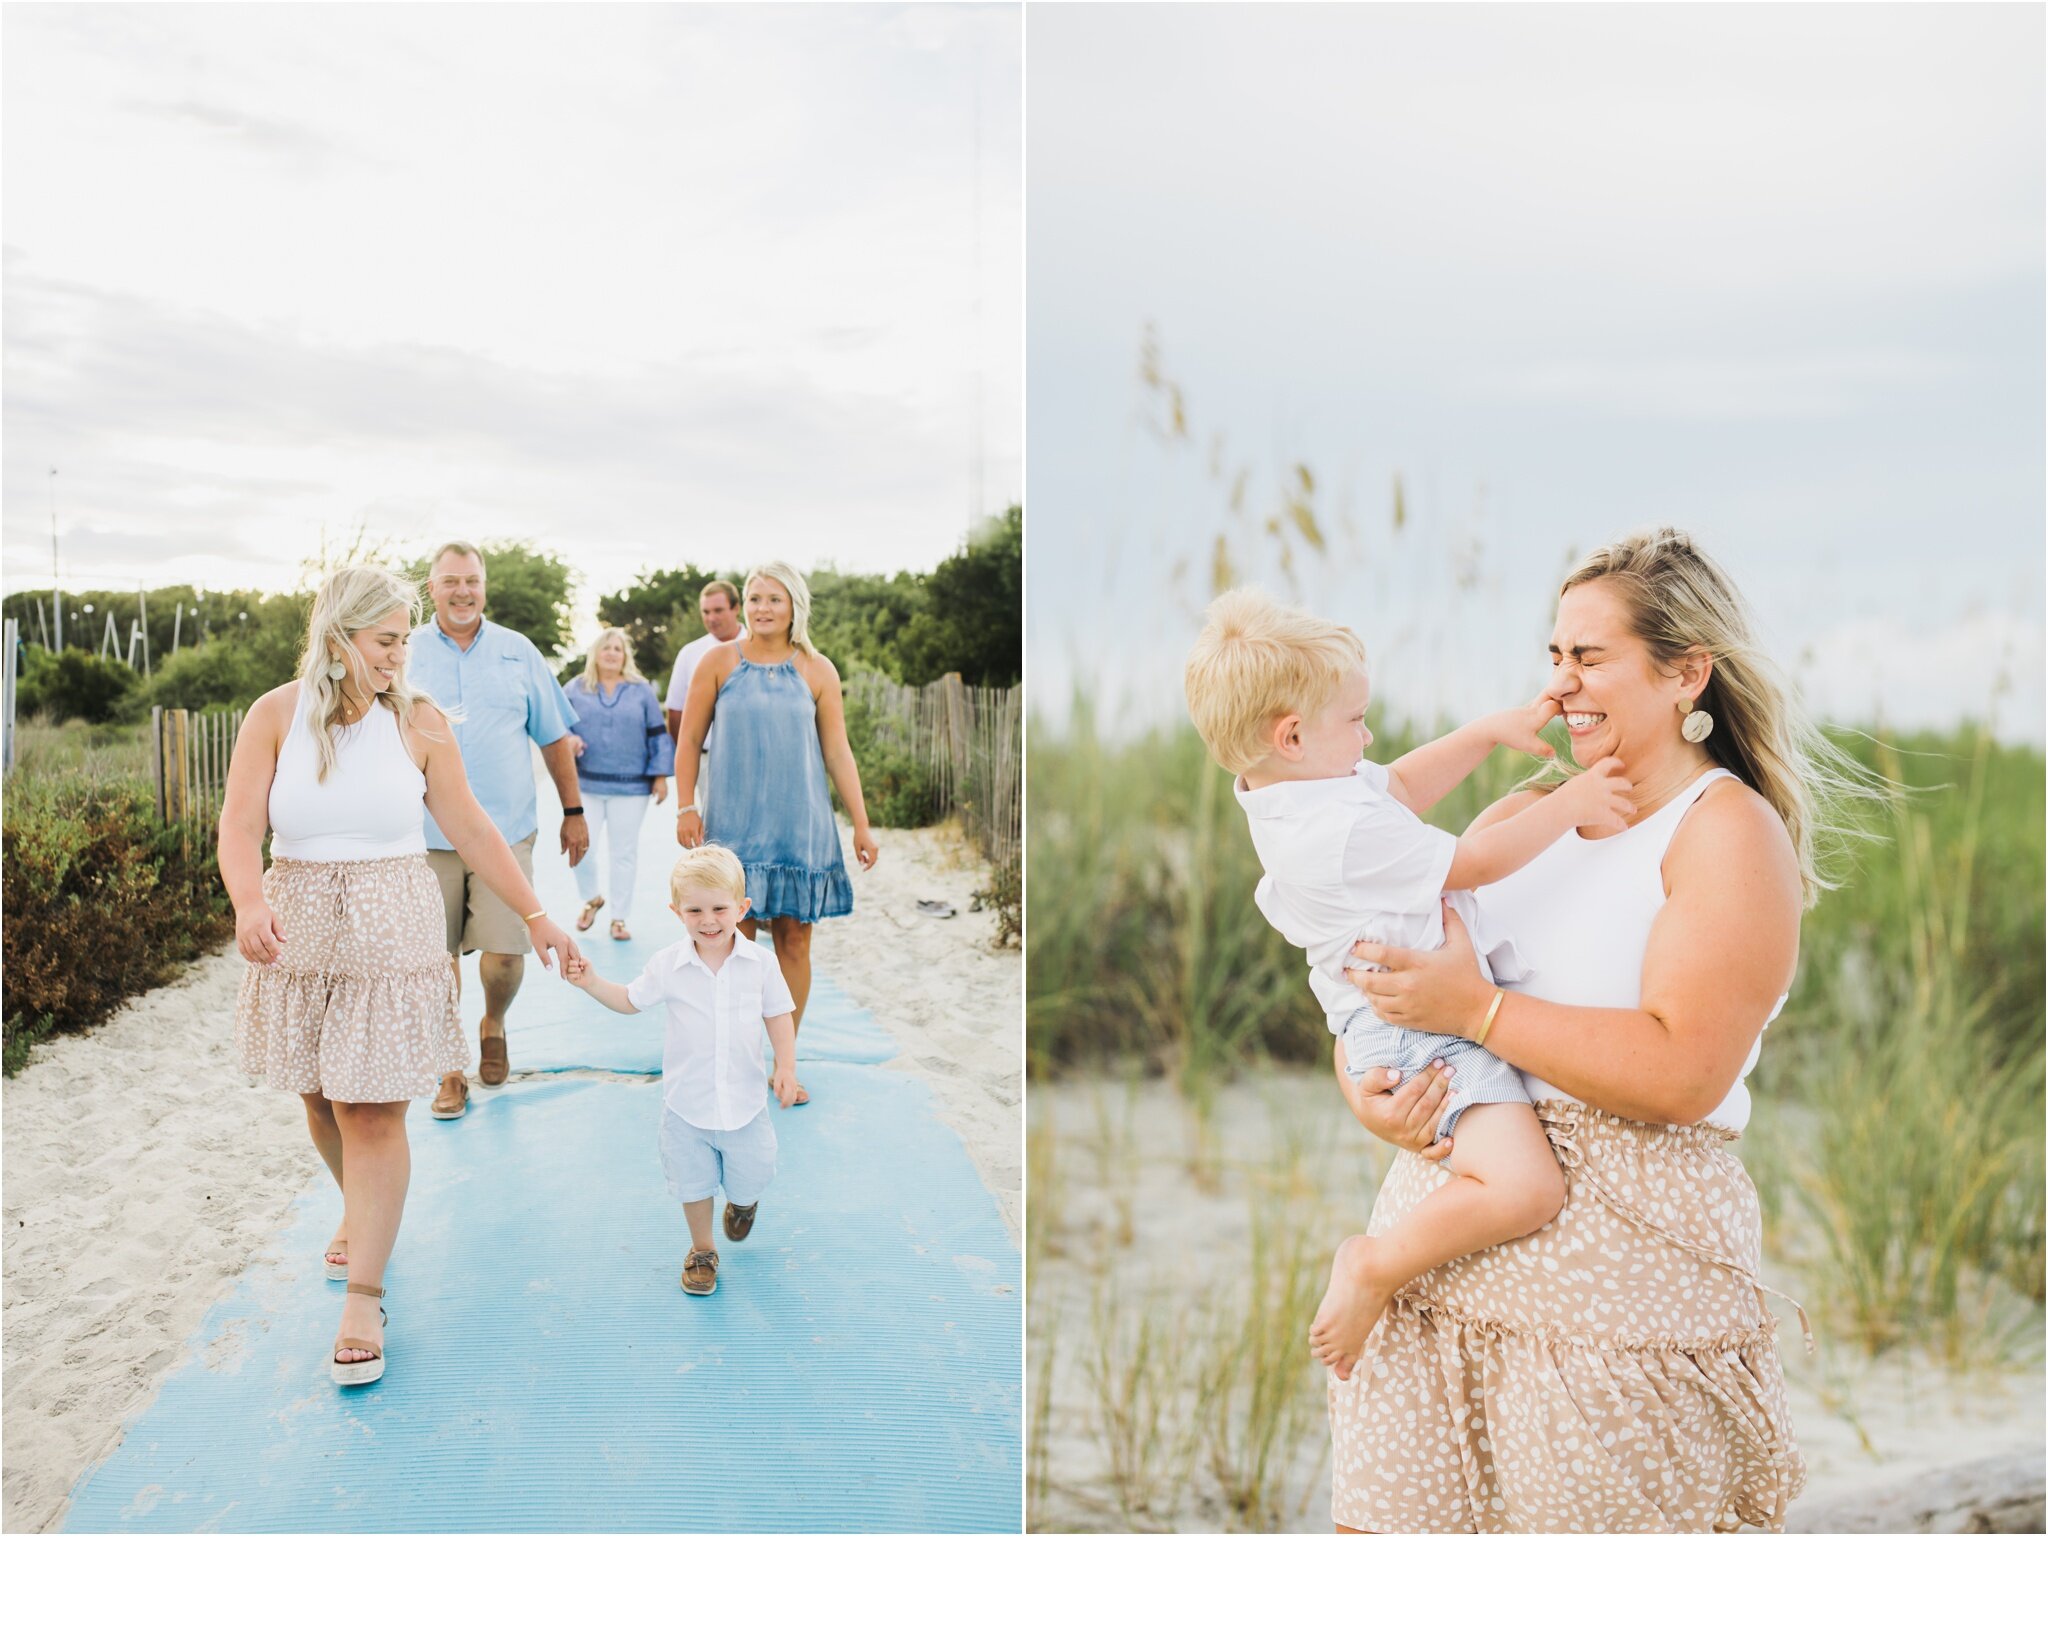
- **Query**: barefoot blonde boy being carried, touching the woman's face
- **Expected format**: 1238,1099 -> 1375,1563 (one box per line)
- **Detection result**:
1186,586 -> 1634,1380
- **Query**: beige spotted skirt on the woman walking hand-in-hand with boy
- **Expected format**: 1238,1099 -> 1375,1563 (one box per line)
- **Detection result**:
236,852 -> 469,1102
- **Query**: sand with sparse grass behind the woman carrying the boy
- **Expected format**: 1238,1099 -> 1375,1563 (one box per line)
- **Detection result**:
1028,1075 -> 2048,1534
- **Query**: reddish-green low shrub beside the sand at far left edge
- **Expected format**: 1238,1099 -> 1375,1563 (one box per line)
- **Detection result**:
0,778 -> 233,1073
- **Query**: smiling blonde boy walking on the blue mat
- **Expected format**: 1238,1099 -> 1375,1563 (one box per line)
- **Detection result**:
567,846 -> 797,1296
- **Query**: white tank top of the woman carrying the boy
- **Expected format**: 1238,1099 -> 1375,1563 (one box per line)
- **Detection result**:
1479,768 -> 1784,1130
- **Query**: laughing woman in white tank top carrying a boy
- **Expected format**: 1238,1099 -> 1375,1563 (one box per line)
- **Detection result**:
1329,530 -> 1853,1532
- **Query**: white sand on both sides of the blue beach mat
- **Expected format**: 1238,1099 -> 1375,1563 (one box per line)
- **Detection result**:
0,807 -> 1022,1532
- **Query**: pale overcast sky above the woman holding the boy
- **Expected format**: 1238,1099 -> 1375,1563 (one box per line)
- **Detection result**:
1028,6 -> 2044,741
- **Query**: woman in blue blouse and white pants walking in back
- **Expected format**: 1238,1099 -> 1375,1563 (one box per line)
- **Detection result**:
567,627 -> 670,942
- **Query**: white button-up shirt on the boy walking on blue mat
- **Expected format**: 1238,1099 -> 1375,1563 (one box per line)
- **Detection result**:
627,932 -> 797,1130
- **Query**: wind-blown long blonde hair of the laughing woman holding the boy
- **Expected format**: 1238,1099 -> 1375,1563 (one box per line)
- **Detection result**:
1536,528 -> 1896,909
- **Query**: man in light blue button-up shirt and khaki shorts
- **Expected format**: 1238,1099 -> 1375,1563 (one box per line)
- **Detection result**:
406,545 -> 590,1120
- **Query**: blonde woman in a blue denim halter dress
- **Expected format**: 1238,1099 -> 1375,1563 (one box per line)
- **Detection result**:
676,563 -> 879,1104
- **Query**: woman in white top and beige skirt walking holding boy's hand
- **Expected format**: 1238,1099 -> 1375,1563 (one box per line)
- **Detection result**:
219,567 -> 575,1386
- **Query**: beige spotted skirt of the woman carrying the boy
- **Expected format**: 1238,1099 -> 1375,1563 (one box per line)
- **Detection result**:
1329,1102 -> 1806,1534
